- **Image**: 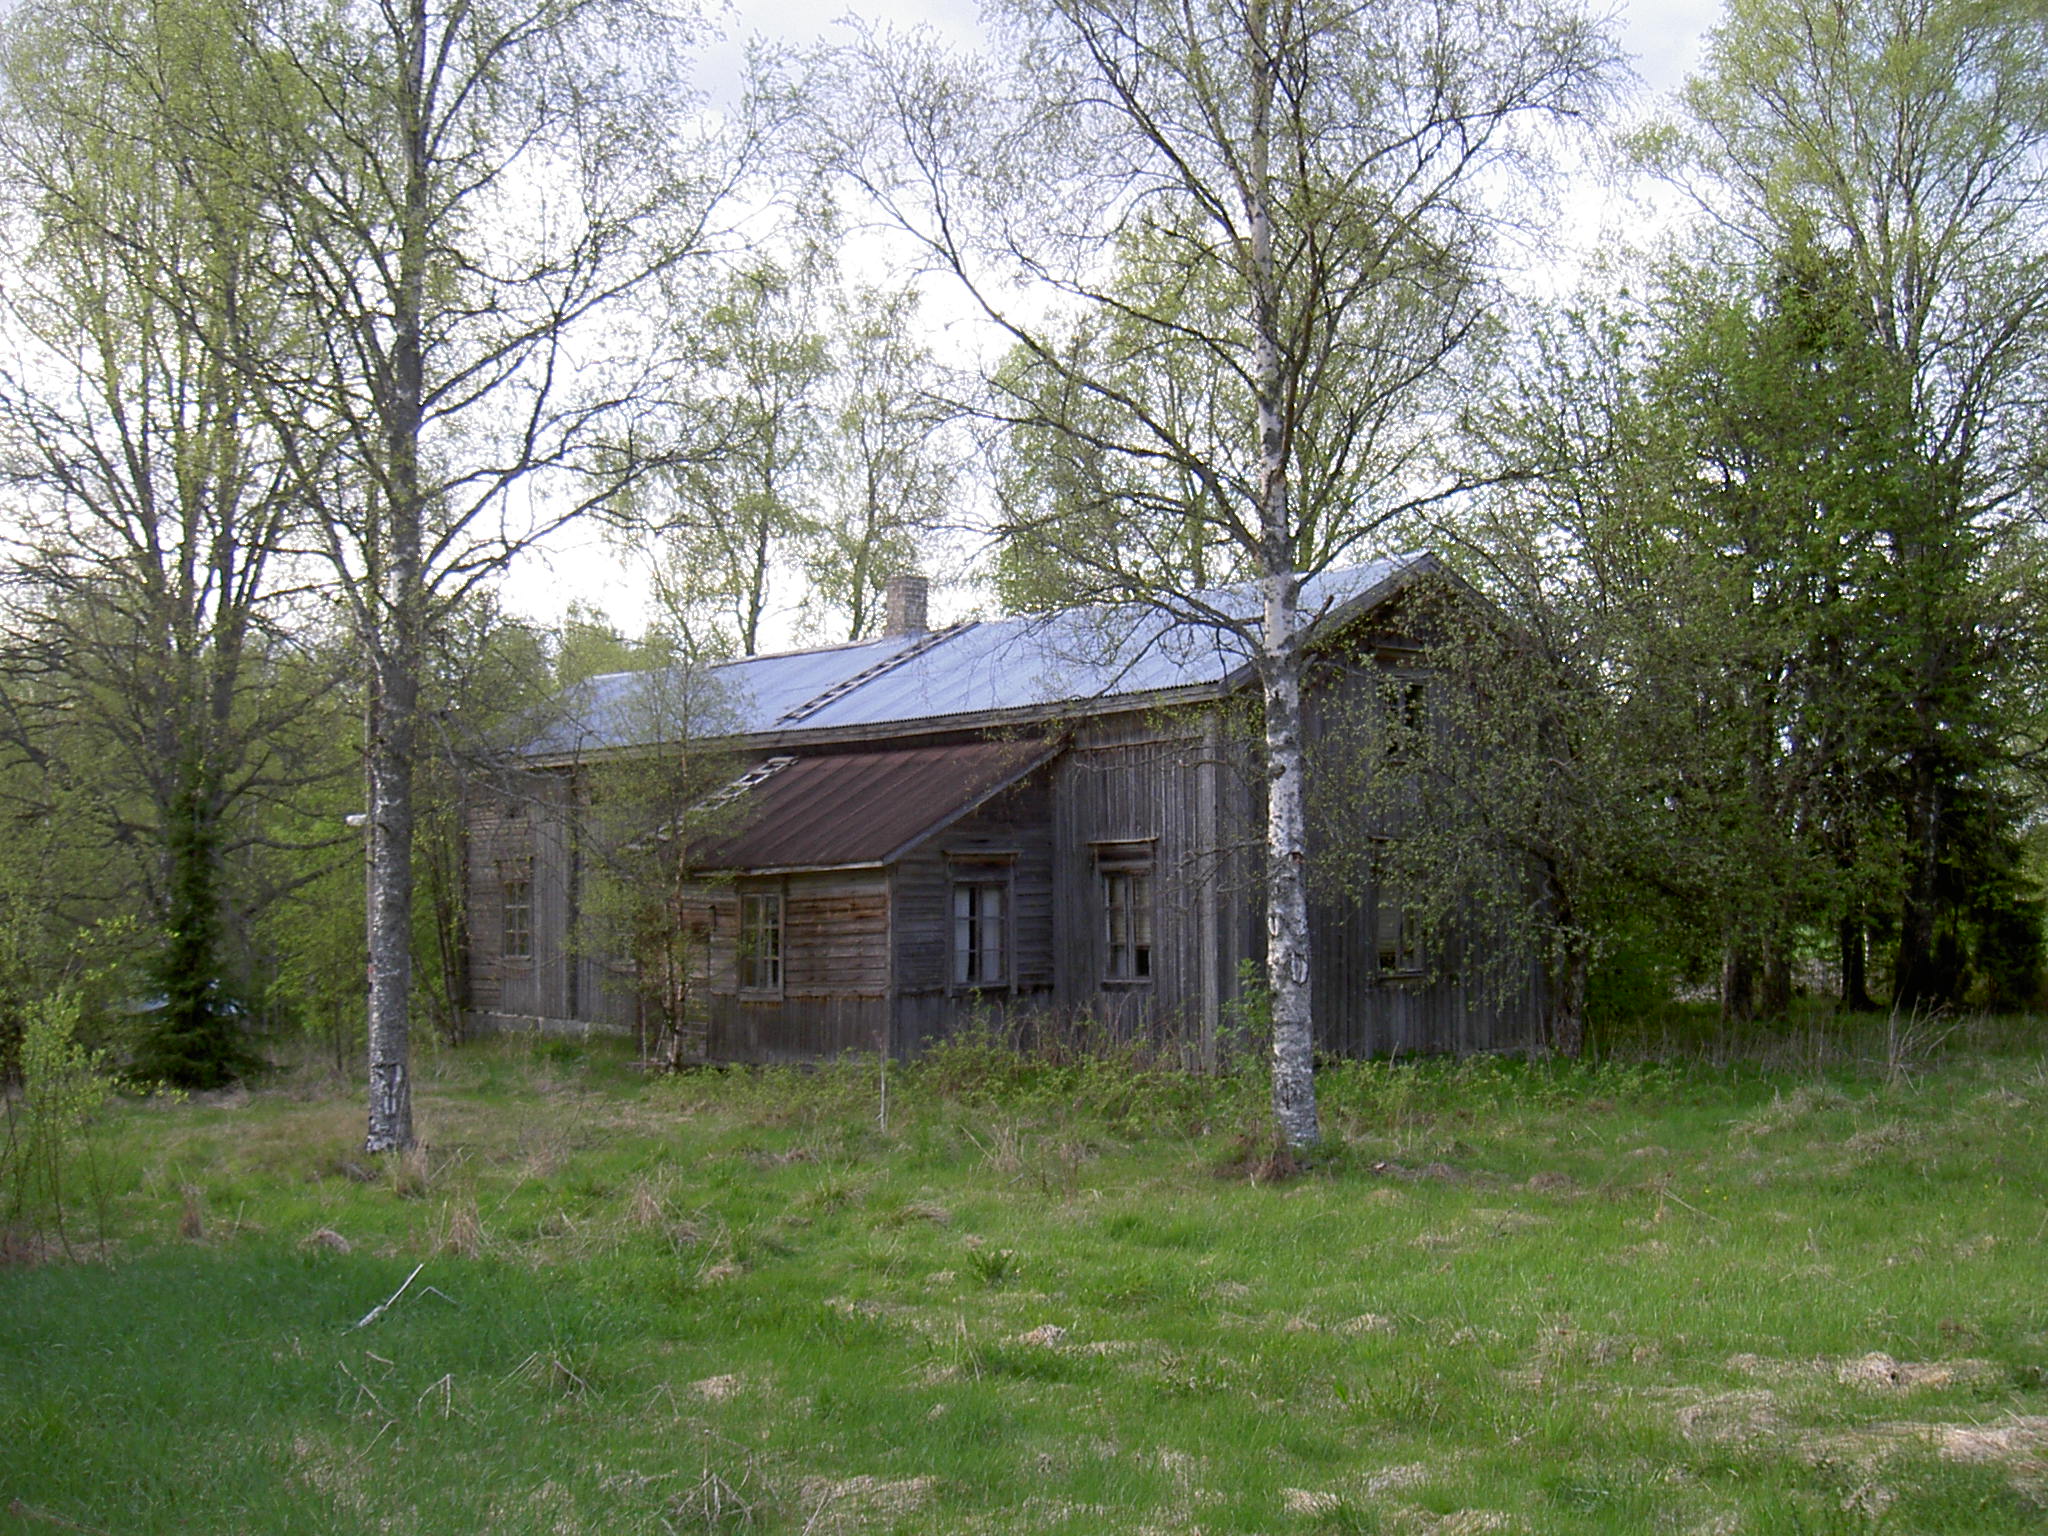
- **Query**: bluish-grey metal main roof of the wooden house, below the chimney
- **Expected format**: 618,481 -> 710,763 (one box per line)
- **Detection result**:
526,553 -> 1436,756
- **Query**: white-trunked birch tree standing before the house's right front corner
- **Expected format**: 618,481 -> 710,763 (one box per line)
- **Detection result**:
836,0 -> 1616,1145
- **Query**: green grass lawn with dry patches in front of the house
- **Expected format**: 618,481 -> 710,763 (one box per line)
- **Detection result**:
0,1032 -> 2048,1536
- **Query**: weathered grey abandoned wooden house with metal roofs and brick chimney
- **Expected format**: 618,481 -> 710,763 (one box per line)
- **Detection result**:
465,553 -> 1540,1063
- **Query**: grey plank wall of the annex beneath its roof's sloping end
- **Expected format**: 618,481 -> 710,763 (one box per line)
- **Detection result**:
889,770 -> 1053,1055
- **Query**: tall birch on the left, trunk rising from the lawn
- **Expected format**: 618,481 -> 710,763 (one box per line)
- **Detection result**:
244,0 -> 745,1151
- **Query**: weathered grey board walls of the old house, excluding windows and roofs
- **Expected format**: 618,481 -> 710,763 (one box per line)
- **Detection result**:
465,606 -> 1542,1065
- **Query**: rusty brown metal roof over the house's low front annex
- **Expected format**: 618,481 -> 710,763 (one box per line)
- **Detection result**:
690,741 -> 1059,870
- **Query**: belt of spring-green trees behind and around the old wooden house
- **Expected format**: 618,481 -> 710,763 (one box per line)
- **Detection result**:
0,0 -> 2048,1149
